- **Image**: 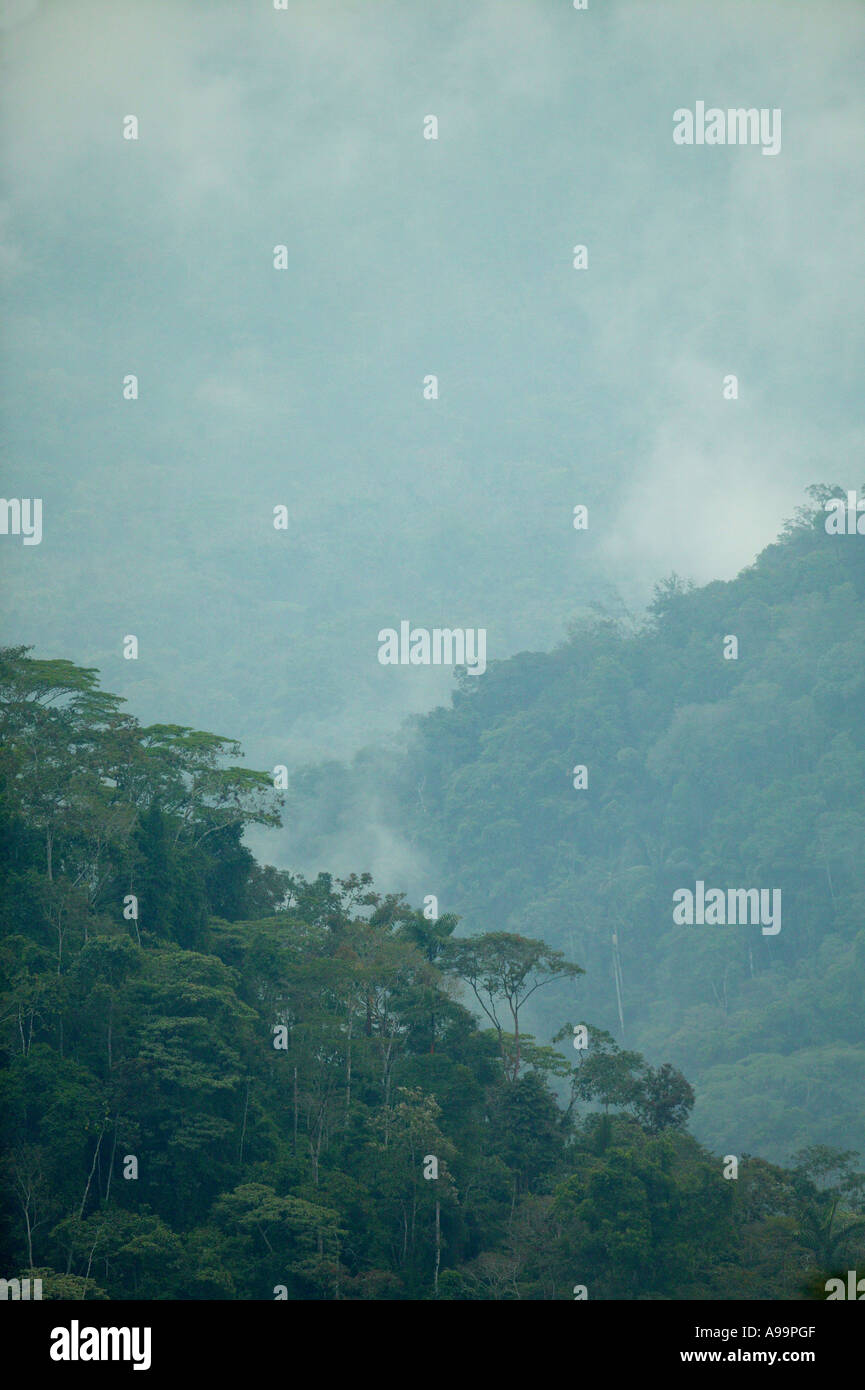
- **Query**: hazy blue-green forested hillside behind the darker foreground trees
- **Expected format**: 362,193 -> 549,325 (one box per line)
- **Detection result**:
289,488 -> 865,1161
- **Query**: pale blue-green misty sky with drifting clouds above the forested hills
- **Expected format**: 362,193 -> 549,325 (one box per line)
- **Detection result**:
0,0 -> 865,817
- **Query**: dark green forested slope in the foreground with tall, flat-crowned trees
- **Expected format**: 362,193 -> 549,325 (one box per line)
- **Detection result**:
0,642 -> 865,1300
